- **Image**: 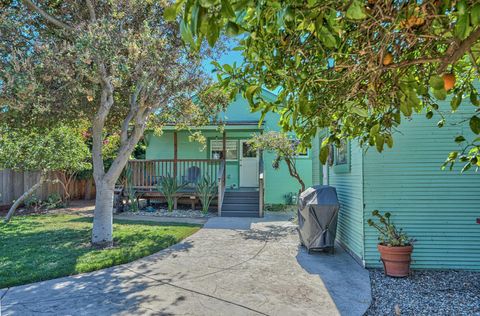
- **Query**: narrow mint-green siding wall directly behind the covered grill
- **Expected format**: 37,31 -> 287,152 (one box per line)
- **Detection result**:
329,142 -> 363,259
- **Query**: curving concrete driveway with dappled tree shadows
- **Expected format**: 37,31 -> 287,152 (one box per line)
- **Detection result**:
0,215 -> 371,316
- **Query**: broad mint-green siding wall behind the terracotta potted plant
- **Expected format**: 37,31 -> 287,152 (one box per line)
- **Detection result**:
364,104 -> 480,270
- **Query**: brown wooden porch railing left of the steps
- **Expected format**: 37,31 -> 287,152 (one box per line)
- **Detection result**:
128,159 -> 224,189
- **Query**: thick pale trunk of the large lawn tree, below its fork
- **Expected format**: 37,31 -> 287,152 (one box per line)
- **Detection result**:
92,181 -> 114,248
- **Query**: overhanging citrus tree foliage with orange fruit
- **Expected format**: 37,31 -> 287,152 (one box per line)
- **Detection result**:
167,0 -> 480,170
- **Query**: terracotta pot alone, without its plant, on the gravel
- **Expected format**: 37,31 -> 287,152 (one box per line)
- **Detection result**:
377,244 -> 413,277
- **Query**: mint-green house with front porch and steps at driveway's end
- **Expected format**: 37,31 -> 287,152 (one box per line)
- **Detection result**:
129,91 -> 316,216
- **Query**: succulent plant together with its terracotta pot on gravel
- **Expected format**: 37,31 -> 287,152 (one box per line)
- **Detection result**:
368,210 -> 414,277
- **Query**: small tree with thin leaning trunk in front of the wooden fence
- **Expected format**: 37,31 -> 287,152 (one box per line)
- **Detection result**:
0,126 -> 90,222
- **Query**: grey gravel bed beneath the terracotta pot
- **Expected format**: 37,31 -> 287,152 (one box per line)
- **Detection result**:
365,270 -> 480,316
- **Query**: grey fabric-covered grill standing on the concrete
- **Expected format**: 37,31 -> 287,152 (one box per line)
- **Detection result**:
298,185 -> 340,250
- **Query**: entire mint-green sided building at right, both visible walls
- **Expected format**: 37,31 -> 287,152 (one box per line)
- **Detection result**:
312,100 -> 480,270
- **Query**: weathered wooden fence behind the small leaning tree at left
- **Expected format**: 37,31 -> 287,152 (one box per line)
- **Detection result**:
0,169 -> 95,208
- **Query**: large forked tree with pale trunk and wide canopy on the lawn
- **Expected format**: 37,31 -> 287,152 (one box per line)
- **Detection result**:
0,0 -> 225,247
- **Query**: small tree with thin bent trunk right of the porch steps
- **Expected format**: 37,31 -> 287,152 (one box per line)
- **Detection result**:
250,132 -> 305,195
